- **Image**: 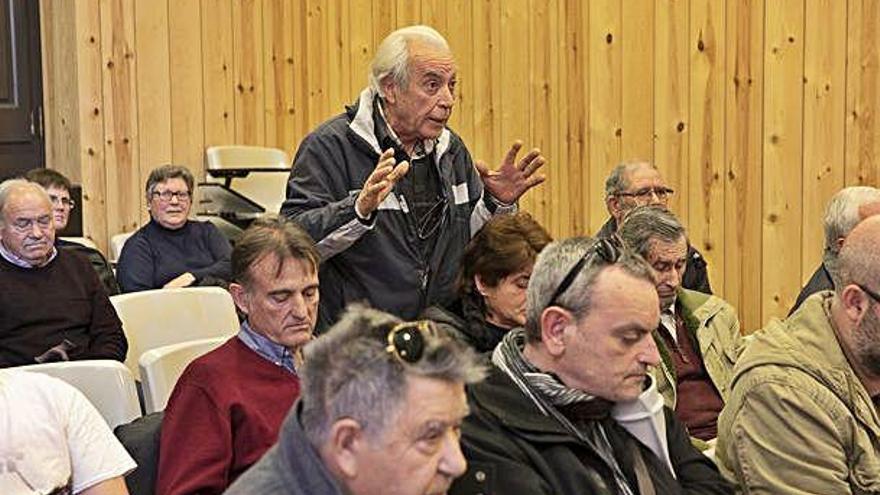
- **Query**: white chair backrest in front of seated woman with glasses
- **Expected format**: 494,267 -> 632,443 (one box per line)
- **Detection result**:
110,287 -> 239,378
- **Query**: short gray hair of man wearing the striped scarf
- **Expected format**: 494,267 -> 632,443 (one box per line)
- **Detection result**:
525,237 -> 656,342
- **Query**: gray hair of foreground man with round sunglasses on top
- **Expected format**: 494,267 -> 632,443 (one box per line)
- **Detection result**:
301,304 -> 485,447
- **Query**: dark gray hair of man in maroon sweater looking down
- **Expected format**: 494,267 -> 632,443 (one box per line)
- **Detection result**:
617,205 -> 687,259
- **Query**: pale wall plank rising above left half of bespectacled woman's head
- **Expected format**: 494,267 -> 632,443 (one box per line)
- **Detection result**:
134,1 -> 171,192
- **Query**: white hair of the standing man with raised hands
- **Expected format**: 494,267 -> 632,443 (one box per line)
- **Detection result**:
369,25 -> 451,96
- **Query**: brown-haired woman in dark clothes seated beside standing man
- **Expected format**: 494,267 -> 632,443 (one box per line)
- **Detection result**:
423,212 -> 553,353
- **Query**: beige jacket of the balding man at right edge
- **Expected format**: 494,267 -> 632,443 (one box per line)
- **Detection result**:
717,291 -> 880,495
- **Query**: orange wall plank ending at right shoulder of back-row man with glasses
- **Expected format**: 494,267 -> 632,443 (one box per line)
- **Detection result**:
686,0 -> 726,293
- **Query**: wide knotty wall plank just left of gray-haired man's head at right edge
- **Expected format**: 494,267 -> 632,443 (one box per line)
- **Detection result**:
761,0 -> 804,321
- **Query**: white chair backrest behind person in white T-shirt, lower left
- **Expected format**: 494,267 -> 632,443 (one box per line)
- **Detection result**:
17,359 -> 141,429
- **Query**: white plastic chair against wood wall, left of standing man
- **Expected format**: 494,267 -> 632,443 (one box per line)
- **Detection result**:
206,146 -> 290,213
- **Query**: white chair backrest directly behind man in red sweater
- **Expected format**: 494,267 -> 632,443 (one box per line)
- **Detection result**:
139,337 -> 228,414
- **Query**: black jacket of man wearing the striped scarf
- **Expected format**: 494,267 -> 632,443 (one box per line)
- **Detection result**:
450,367 -> 733,495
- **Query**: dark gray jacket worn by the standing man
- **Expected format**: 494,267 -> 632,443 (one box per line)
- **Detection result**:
281,89 -> 512,329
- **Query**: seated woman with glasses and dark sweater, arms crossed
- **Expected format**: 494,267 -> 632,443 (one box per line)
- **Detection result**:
116,165 -> 232,292
